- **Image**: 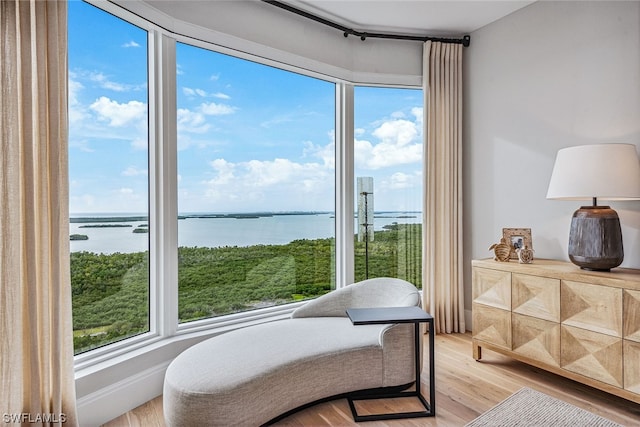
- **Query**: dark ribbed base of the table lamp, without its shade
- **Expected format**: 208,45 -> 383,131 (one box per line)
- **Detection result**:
569,206 -> 624,271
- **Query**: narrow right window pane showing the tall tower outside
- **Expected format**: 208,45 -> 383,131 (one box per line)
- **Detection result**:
354,87 -> 423,287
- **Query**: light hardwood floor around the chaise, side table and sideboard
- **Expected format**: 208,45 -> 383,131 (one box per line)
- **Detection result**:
100,334 -> 640,427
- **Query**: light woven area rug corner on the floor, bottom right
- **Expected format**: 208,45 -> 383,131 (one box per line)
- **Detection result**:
465,387 -> 622,427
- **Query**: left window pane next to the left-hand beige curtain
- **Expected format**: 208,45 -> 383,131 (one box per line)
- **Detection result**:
68,1 -> 149,354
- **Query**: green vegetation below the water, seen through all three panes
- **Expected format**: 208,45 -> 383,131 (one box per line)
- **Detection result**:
71,224 -> 421,354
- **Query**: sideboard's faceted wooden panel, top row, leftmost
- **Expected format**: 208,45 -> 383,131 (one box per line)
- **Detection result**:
472,268 -> 511,311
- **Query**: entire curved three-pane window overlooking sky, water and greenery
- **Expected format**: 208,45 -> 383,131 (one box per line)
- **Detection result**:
69,2 -> 423,362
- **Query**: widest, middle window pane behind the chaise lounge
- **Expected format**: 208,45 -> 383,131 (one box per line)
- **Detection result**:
176,43 -> 335,322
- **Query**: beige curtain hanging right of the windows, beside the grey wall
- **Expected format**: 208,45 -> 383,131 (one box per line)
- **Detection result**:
422,41 -> 465,333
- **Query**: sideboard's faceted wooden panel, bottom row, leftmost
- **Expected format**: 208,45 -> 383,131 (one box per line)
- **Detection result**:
472,303 -> 511,350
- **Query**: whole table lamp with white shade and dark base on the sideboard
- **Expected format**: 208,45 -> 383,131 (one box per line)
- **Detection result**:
547,144 -> 640,271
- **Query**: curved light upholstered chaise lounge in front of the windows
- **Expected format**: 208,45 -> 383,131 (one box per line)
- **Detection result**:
163,278 -> 420,426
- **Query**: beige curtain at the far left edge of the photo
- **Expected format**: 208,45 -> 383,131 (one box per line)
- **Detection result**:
0,0 -> 77,426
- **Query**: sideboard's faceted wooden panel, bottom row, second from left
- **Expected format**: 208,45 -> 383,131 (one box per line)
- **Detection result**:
511,314 -> 560,368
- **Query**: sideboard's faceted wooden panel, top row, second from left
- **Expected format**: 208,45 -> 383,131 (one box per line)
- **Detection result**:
511,273 -> 560,322
